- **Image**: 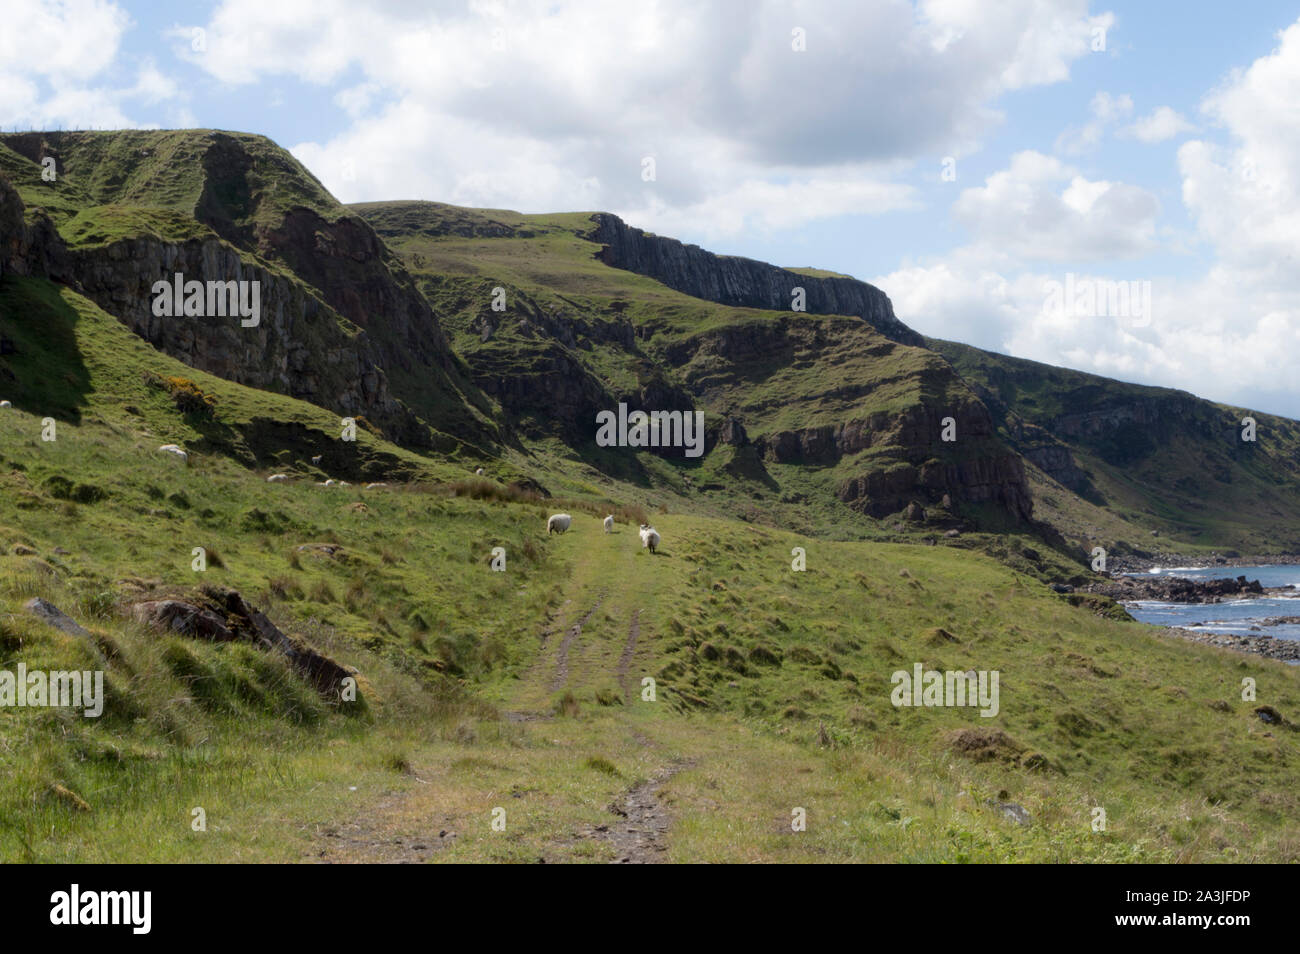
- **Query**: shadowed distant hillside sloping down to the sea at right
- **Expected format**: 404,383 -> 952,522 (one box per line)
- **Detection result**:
928,341 -> 1300,552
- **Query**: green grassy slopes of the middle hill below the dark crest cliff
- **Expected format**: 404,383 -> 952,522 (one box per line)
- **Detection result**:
350,201 -> 1013,537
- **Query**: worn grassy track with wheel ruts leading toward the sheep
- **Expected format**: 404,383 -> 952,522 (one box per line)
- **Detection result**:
309,515 -> 692,863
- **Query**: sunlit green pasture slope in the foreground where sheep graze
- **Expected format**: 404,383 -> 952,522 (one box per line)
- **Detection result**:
0,279 -> 1300,860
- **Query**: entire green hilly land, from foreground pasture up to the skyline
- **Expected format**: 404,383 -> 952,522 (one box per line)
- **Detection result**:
0,131 -> 1300,862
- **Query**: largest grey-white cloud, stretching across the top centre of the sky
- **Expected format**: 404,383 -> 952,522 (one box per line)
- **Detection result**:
188,0 -> 1110,223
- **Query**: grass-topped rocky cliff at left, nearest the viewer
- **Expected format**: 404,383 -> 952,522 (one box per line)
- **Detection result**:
0,130 -> 501,448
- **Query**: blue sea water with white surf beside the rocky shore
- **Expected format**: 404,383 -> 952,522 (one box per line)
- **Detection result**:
1127,564 -> 1300,639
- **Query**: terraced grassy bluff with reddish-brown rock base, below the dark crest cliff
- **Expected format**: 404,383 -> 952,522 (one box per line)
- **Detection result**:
666,317 -> 1034,522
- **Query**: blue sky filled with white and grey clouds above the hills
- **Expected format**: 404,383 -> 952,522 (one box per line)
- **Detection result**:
0,0 -> 1300,417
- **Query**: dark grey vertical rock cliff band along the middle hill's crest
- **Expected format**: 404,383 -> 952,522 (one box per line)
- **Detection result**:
588,212 -> 924,347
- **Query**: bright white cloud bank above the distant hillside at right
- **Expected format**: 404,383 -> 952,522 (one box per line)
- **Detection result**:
872,23 -> 1300,417
